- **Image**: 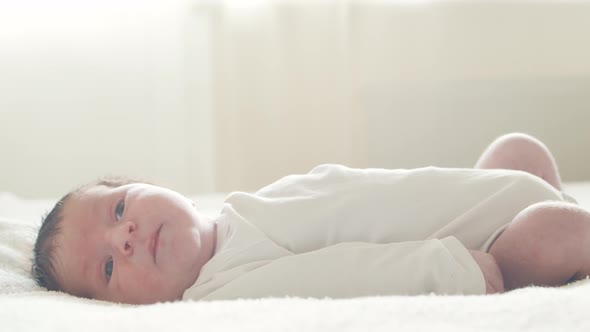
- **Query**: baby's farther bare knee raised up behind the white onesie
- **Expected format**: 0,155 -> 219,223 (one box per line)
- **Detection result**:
475,133 -> 561,190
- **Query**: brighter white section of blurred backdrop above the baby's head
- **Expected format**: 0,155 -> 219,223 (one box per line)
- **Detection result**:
0,0 -> 215,197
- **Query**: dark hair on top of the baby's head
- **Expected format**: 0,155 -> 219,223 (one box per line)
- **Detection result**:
31,177 -> 144,291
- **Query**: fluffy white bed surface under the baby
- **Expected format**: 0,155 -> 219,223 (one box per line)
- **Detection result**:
0,182 -> 590,332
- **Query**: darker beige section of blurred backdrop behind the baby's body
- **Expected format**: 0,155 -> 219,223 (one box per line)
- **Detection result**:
211,0 -> 590,190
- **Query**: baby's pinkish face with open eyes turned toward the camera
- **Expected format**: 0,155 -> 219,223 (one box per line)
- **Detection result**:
54,184 -> 216,304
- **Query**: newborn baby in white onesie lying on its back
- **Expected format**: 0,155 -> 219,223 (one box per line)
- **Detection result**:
32,134 -> 590,304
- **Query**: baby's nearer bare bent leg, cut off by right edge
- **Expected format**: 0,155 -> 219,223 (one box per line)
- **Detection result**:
489,202 -> 590,290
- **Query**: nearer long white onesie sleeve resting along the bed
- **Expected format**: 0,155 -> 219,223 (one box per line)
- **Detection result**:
203,237 -> 485,300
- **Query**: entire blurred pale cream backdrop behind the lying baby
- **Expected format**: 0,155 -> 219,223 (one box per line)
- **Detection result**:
0,0 -> 590,198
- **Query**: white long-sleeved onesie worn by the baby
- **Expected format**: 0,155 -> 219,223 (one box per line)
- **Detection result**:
183,165 -> 564,300
